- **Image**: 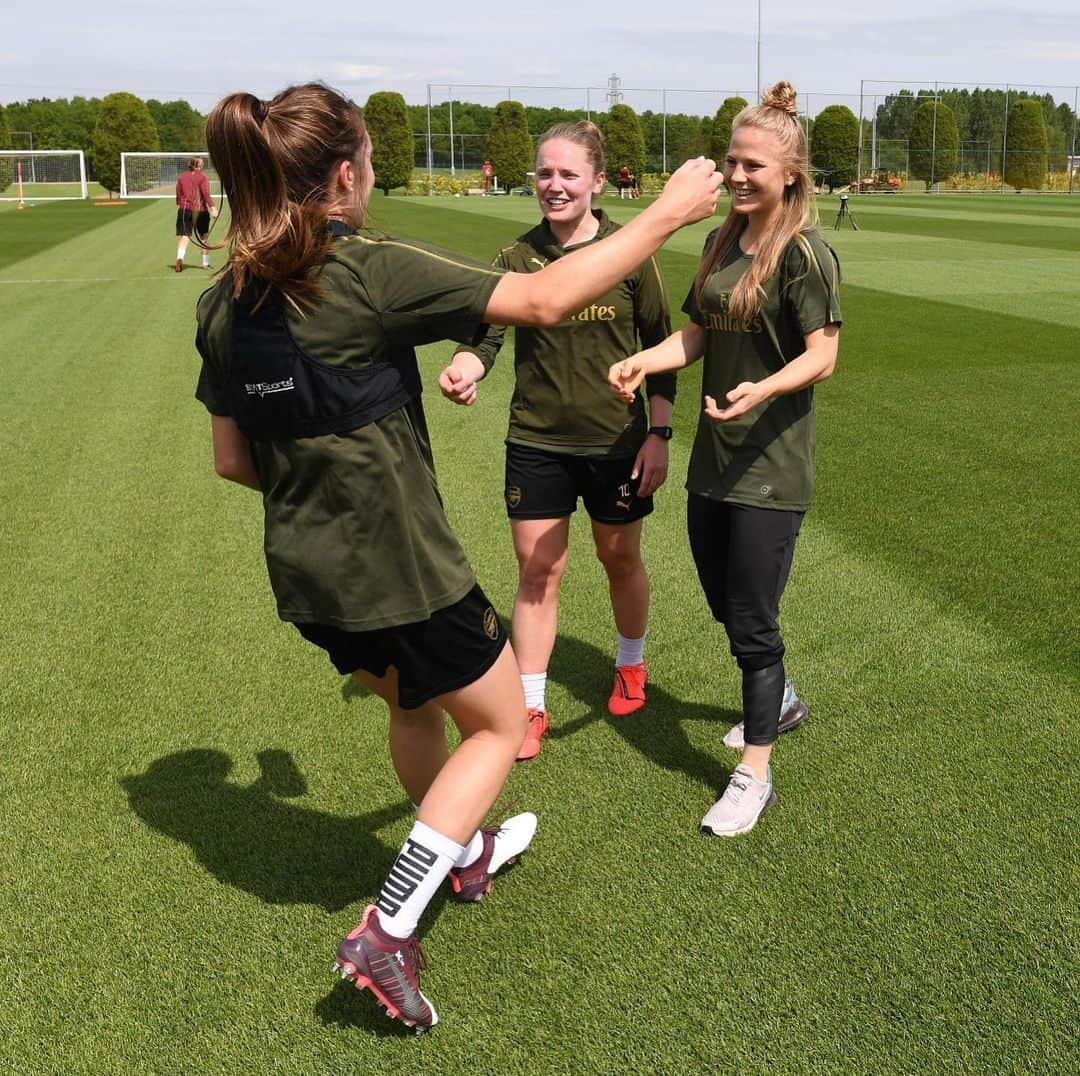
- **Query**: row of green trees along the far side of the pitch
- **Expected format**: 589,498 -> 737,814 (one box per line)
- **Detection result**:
0,89 -> 1076,190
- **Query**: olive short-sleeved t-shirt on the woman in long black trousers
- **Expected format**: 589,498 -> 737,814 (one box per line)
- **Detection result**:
683,229 -> 840,511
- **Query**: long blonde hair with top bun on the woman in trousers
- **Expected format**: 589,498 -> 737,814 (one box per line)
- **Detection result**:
693,82 -> 818,321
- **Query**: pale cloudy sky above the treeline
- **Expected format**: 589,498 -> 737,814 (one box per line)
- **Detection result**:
6,0 -> 1080,113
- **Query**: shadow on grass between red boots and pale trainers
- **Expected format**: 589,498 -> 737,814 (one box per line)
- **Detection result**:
548,635 -> 742,795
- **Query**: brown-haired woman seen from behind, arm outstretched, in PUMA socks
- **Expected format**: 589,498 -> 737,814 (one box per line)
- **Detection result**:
195,84 -> 719,1031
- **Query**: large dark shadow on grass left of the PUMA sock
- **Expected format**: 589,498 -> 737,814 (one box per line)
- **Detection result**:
120,749 -> 413,912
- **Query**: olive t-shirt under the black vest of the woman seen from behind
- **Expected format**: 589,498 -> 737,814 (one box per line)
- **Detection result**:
195,234 -> 500,631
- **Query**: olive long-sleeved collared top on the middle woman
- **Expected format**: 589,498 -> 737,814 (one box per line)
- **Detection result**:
457,210 -> 675,457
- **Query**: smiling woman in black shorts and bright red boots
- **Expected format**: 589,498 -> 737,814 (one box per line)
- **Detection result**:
440,120 -> 675,761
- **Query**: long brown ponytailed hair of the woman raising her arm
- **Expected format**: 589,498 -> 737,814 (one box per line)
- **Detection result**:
206,83 -> 367,306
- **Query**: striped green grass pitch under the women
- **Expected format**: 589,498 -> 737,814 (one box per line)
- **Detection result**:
0,194 -> 1080,1076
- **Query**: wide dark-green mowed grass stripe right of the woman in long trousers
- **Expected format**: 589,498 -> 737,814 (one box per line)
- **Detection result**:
812,287 -> 1080,678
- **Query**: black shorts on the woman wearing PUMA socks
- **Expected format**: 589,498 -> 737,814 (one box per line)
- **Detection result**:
296,584 -> 507,710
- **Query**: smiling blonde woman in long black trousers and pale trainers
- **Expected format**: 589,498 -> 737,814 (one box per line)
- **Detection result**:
609,82 -> 840,836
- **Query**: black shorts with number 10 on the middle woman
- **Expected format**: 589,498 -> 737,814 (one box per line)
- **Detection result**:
503,444 -> 652,523
